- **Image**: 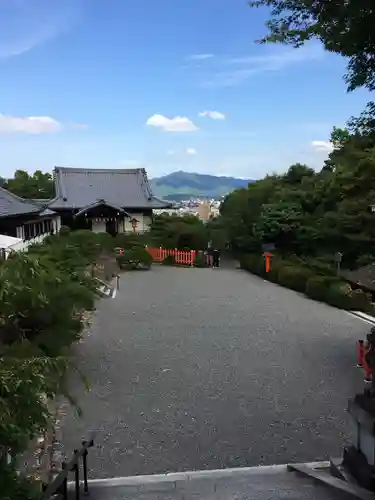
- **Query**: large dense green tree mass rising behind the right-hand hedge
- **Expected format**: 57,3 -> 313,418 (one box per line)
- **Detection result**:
217,103 -> 375,268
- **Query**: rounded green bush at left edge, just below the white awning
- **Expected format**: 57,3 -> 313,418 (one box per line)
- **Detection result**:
0,254 -> 94,356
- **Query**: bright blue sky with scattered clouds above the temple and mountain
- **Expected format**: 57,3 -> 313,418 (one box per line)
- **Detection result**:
0,0 -> 369,178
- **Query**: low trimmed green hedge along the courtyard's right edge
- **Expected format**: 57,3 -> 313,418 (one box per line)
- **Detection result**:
240,254 -> 372,312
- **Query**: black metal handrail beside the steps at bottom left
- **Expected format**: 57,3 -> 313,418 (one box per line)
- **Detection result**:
41,439 -> 94,500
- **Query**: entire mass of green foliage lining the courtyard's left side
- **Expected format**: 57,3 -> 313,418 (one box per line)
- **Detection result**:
0,231 -> 110,499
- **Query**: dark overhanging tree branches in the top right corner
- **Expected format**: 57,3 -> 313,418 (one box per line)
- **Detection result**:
249,0 -> 375,90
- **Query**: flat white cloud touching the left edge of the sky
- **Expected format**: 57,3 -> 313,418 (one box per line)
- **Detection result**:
0,114 -> 62,134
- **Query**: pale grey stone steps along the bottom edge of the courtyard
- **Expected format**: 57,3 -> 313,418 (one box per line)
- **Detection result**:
69,462 -> 366,500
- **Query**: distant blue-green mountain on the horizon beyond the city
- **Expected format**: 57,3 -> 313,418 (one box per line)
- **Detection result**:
150,171 -> 252,201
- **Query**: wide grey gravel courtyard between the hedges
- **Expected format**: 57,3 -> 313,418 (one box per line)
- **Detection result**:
63,266 -> 369,478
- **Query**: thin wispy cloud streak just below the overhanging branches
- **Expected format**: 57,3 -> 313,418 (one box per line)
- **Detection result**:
204,43 -> 324,87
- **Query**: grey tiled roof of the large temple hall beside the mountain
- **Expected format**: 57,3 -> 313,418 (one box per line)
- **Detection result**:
49,167 -> 169,209
